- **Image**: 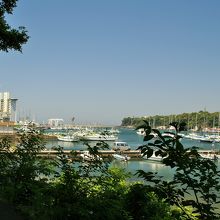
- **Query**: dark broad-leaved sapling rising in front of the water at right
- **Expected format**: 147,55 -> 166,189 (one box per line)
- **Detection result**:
138,122 -> 220,219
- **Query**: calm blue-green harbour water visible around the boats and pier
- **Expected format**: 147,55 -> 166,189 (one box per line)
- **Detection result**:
46,128 -> 220,175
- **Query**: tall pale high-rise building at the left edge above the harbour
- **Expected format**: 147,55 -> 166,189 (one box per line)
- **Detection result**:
0,92 -> 18,121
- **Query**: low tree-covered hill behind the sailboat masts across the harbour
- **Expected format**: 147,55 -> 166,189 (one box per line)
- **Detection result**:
121,111 -> 220,130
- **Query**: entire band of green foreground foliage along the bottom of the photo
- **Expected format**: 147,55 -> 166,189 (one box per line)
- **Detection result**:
0,128 -> 219,220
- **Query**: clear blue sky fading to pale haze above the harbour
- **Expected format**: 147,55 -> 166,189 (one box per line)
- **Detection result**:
0,0 -> 220,125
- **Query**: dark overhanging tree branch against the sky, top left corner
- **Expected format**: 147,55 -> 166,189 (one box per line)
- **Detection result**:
0,0 -> 29,52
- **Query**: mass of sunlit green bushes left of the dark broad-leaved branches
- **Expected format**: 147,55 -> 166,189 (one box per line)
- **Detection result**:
0,131 -> 177,220
